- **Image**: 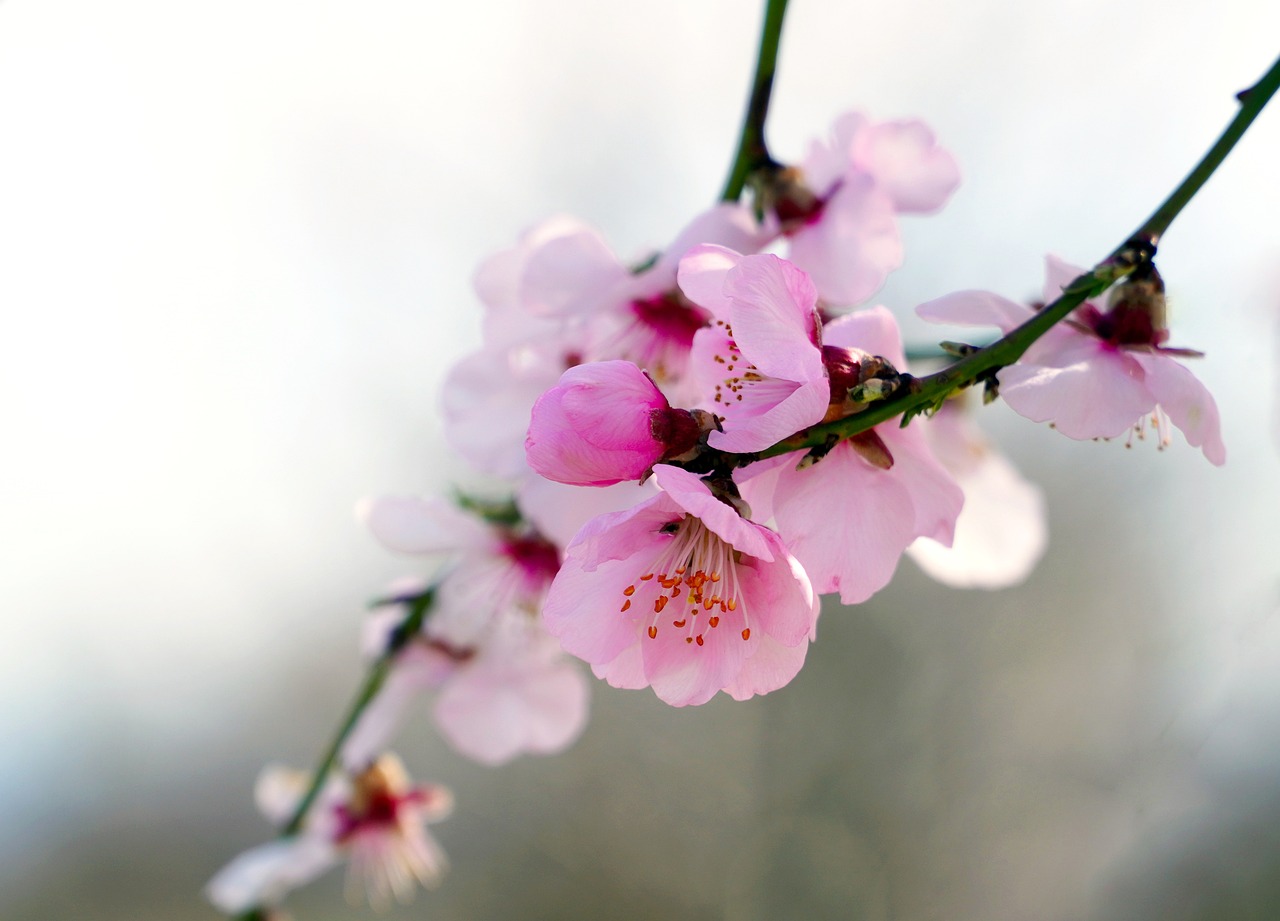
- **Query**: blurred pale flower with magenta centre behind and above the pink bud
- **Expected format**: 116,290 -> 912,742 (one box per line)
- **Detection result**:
443,203 -> 765,478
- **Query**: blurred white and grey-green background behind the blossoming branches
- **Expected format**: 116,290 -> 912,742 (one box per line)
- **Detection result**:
0,0 -> 1280,921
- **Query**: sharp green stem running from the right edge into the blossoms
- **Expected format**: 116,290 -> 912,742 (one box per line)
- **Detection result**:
742,54 -> 1280,467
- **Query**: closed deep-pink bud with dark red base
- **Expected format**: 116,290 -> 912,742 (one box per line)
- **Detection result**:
525,361 -> 701,486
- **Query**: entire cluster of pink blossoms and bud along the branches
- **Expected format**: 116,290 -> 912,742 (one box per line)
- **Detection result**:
209,106 -> 1225,912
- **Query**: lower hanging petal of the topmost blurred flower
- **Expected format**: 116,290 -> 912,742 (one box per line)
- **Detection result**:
788,173 -> 902,306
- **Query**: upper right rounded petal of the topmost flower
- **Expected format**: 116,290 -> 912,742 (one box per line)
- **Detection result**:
854,120 -> 960,214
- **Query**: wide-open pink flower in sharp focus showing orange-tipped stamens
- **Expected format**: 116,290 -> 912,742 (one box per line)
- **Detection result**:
543,464 -> 818,706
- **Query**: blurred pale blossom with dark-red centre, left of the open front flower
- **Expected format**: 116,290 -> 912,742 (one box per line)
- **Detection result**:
343,498 -> 589,764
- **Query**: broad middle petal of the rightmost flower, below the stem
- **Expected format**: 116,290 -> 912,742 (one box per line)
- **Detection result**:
998,340 -> 1156,439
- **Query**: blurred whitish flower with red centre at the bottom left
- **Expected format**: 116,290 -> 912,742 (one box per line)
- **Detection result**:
205,755 -> 453,915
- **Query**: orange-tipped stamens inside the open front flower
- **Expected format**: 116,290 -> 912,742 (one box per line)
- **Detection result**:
620,514 -> 751,647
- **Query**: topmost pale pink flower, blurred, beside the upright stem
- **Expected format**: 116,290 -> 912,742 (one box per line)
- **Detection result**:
778,113 -> 960,304
